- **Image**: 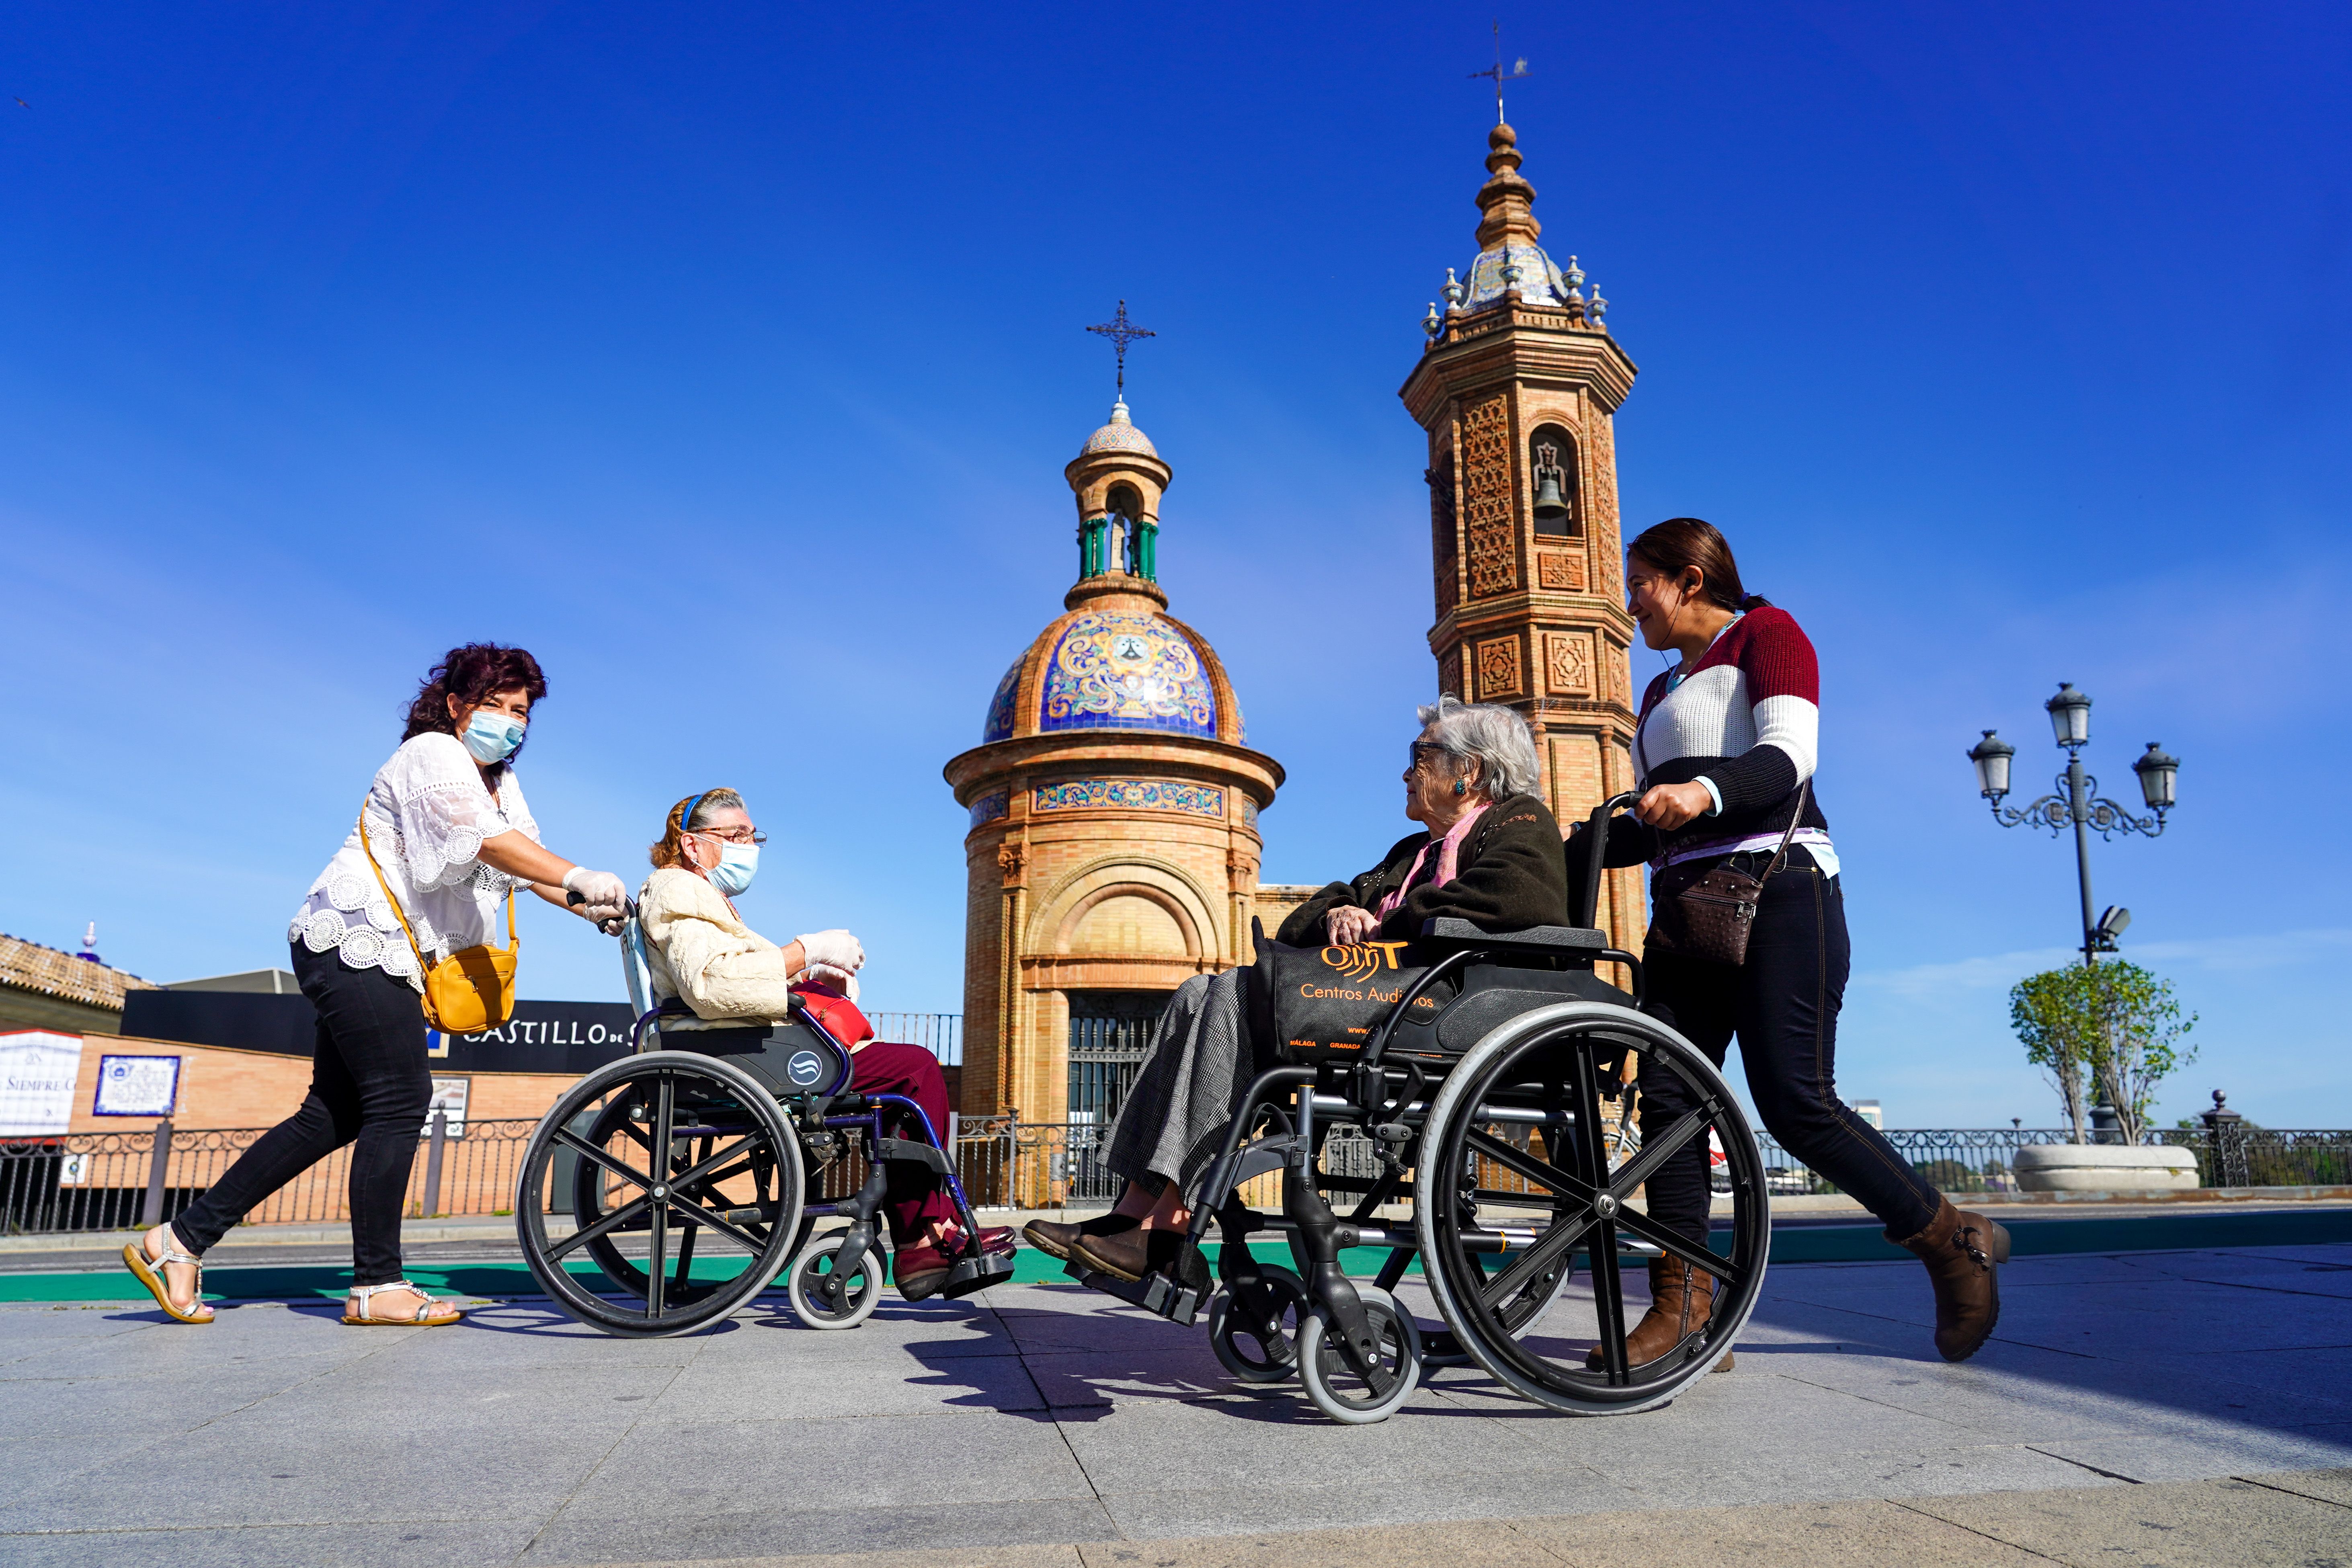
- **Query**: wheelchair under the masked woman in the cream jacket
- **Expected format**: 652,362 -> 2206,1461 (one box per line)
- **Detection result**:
515,905 -> 1014,1338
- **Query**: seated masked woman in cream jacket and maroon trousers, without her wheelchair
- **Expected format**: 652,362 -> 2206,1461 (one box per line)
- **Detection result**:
638,790 -> 1014,1300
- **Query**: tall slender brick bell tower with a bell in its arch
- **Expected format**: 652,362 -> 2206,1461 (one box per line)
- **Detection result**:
1399,125 -> 1644,952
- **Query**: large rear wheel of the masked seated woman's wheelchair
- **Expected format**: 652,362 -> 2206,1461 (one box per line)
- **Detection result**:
515,1051 -> 804,1338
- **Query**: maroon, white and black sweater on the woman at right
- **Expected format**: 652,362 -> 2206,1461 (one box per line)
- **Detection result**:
1609,604 -> 1837,877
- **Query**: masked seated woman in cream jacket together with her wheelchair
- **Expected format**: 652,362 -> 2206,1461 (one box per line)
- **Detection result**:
515,790 -> 1014,1333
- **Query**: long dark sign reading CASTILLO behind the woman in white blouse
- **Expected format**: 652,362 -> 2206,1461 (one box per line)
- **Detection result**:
122,990 -> 635,1074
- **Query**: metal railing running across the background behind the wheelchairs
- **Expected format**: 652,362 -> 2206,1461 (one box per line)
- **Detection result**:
18,1123 -> 2352,1234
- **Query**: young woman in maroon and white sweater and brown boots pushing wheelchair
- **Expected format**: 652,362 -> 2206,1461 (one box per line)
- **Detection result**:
1569,517 -> 2009,1366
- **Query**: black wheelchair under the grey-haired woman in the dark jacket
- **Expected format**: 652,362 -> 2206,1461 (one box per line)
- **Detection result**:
1066,795 -> 1771,1425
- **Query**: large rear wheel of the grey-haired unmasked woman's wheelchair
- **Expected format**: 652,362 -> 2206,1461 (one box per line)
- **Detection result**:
1413,1001 -> 1771,1415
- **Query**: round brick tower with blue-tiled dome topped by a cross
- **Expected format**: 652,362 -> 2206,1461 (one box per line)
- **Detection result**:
945,397 -> 1296,1126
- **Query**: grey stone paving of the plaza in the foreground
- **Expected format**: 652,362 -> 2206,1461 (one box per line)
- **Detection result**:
0,1246 -> 2352,1568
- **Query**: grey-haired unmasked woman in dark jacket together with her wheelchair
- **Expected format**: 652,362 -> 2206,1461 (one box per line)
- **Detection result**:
1028,698 -> 1769,1422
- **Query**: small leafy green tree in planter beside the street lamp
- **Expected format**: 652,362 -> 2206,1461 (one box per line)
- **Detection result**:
2009,959 -> 2197,1142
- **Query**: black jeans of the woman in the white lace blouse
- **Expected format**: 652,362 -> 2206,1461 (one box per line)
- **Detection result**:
172,943 -> 433,1286
